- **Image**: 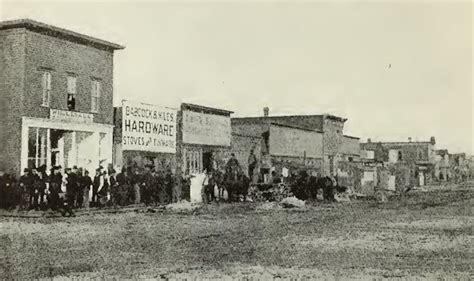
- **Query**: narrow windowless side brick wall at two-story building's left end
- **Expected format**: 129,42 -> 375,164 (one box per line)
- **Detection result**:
0,29 -> 26,175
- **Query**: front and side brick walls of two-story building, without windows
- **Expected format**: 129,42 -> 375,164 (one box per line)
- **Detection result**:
0,28 -> 117,175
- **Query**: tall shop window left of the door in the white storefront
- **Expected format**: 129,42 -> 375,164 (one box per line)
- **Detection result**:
28,127 -> 48,168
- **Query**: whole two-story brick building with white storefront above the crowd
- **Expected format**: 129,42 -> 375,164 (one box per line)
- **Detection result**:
0,20 -> 124,174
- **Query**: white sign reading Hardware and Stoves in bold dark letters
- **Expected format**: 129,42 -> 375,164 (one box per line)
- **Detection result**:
122,100 -> 177,153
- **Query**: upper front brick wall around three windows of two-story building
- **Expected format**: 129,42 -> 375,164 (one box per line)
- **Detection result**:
23,31 -> 113,124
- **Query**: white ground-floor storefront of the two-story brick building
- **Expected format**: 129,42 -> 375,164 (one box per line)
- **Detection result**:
21,109 -> 113,174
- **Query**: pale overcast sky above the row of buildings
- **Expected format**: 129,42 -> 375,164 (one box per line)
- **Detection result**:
0,0 -> 474,153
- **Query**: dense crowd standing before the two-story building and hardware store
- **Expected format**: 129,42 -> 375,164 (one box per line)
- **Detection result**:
0,163 -> 175,215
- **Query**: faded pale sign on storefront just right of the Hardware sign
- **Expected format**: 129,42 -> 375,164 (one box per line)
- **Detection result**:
183,110 -> 231,146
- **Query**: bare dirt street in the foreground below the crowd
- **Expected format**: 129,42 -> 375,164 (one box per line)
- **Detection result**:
0,185 -> 474,280
